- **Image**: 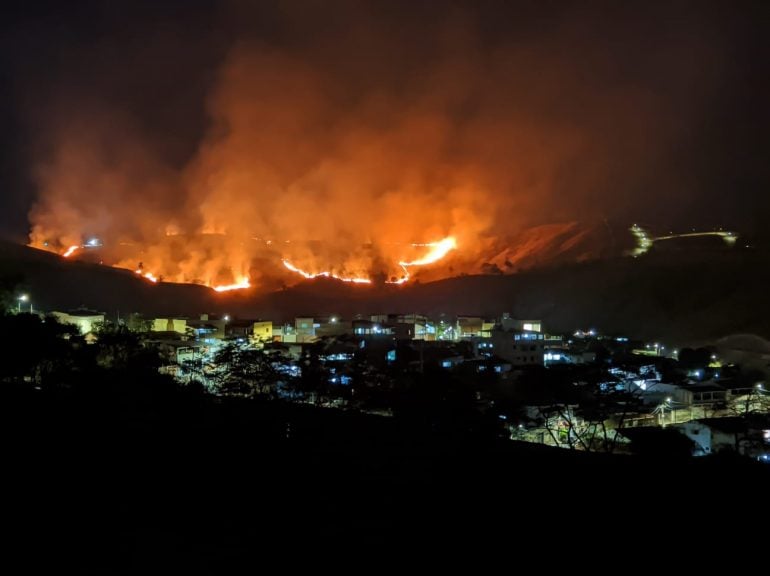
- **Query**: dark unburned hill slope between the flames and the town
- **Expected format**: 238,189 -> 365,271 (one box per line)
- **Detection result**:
0,244 -> 770,340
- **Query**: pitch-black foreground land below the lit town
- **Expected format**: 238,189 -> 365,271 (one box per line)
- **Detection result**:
0,382 -> 770,574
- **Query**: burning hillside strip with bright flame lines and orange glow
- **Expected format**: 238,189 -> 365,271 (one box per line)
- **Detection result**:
33,222 -> 614,292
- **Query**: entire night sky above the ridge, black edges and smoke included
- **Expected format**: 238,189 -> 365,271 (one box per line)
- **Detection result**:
0,0 -> 770,240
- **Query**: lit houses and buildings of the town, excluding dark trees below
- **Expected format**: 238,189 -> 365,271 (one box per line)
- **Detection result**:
46,310 -> 770,458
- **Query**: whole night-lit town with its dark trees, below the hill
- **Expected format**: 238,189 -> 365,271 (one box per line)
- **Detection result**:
9,295 -> 770,462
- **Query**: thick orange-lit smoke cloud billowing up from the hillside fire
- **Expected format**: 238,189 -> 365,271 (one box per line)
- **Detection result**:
24,2 -> 744,286
